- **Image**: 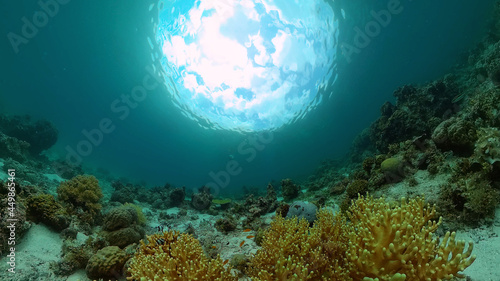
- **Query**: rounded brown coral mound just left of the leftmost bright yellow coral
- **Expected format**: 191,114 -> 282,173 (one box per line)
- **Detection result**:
85,246 -> 129,279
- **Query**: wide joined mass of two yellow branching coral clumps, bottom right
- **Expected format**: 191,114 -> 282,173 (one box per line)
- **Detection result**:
248,197 -> 475,281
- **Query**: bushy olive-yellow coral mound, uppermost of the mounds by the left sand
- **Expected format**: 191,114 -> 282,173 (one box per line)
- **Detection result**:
57,175 -> 102,224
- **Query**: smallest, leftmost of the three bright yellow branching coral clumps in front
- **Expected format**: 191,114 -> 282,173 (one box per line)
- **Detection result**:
127,231 -> 237,281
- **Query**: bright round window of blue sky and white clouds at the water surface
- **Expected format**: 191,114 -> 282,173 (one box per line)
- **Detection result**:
156,1 -> 339,132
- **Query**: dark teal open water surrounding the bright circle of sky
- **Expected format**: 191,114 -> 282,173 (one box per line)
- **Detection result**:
0,0 -> 493,195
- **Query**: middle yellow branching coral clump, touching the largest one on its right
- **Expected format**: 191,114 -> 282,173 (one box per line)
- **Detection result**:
249,207 -> 350,281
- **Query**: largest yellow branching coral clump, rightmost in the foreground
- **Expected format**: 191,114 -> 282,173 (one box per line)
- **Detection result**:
346,197 -> 475,281
